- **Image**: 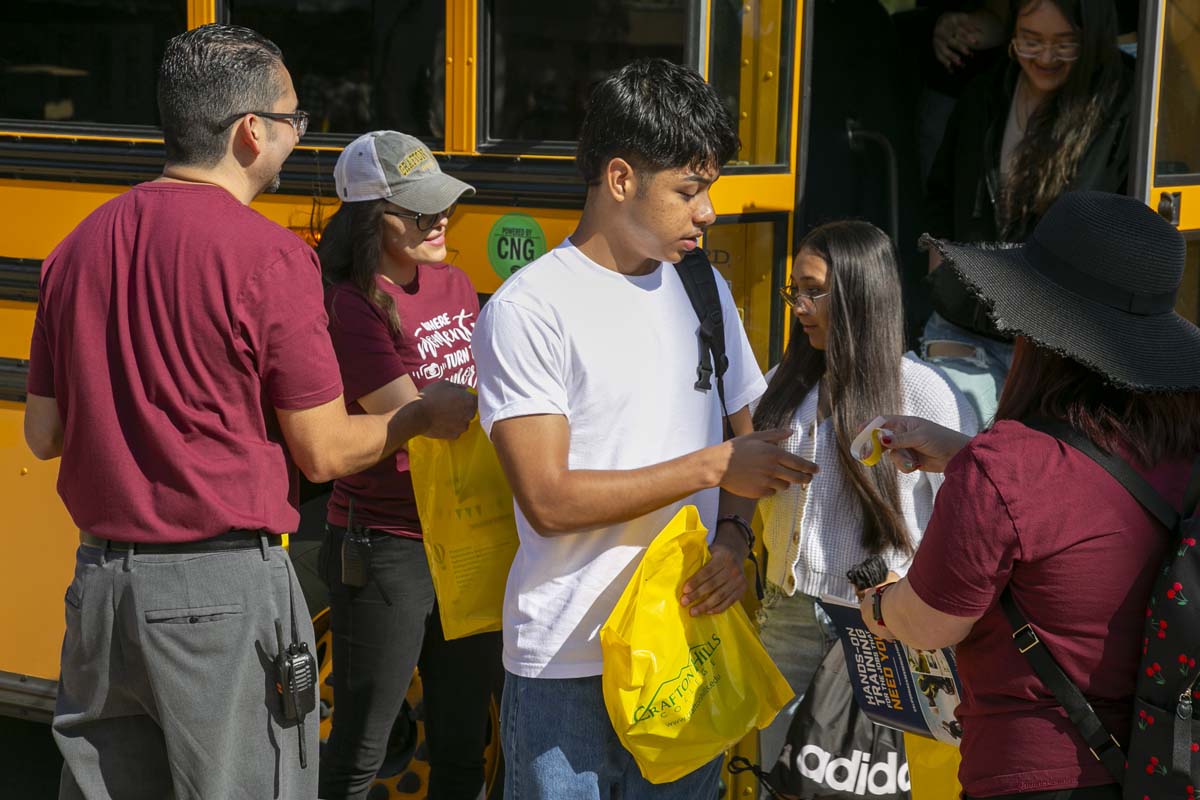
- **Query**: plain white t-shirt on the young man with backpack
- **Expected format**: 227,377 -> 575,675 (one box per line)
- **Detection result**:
472,240 -> 766,678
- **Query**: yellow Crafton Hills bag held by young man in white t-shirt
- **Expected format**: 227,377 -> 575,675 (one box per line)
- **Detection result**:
600,506 -> 792,783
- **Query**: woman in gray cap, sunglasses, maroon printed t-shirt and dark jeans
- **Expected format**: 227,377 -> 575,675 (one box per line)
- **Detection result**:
318,131 -> 500,800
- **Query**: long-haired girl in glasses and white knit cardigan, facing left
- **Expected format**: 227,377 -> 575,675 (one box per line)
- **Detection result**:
755,221 -> 978,764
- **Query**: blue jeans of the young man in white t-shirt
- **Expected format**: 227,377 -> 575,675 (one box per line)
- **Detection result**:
500,673 -> 722,800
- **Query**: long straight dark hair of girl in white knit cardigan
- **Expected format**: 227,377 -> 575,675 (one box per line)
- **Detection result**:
754,222 -> 912,553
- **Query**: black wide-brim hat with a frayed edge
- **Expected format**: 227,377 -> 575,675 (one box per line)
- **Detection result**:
922,192 -> 1200,391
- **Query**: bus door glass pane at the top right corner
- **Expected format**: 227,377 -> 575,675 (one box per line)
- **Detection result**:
1154,0 -> 1200,178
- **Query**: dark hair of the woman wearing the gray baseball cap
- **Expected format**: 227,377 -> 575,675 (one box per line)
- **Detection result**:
317,200 -> 401,333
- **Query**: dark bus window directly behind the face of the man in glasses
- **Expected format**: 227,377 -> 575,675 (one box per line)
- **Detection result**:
229,0 -> 446,144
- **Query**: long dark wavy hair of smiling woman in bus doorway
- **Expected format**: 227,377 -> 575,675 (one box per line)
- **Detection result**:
1000,0 -> 1123,239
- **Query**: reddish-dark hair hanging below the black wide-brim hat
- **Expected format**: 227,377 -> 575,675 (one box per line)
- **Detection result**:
996,336 -> 1200,467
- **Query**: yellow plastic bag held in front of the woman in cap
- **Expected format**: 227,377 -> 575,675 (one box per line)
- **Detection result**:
408,417 -> 517,639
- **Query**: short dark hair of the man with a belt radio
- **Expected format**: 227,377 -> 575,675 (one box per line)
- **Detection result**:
158,24 -> 283,167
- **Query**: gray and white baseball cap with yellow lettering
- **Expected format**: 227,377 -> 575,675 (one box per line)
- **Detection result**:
334,131 -> 475,213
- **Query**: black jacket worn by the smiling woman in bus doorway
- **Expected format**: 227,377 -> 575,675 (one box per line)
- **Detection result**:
925,59 -> 1134,338
